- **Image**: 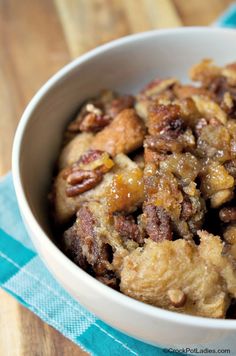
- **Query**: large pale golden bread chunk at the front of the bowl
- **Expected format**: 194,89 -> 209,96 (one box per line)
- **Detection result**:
118,232 -> 236,318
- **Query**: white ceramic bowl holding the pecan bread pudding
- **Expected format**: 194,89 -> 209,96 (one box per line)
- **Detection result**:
13,28 -> 236,353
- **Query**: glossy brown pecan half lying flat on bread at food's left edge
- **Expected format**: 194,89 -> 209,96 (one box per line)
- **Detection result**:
66,169 -> 103,197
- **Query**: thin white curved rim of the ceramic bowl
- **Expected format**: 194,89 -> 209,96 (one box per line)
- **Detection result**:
12,27 -> 236,330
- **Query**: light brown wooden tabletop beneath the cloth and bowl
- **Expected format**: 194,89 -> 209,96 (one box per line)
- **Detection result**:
0,0 -> 232,356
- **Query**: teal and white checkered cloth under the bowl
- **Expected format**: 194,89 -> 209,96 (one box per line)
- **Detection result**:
0,5 -> 236,356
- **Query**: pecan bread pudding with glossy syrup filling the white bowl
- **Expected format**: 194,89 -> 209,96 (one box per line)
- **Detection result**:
51,60 -> 236,318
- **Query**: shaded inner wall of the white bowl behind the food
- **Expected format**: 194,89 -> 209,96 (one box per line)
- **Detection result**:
17,28 -> 236,237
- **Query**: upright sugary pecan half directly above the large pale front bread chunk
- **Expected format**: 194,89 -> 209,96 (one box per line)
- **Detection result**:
144,204 -> 172,242
